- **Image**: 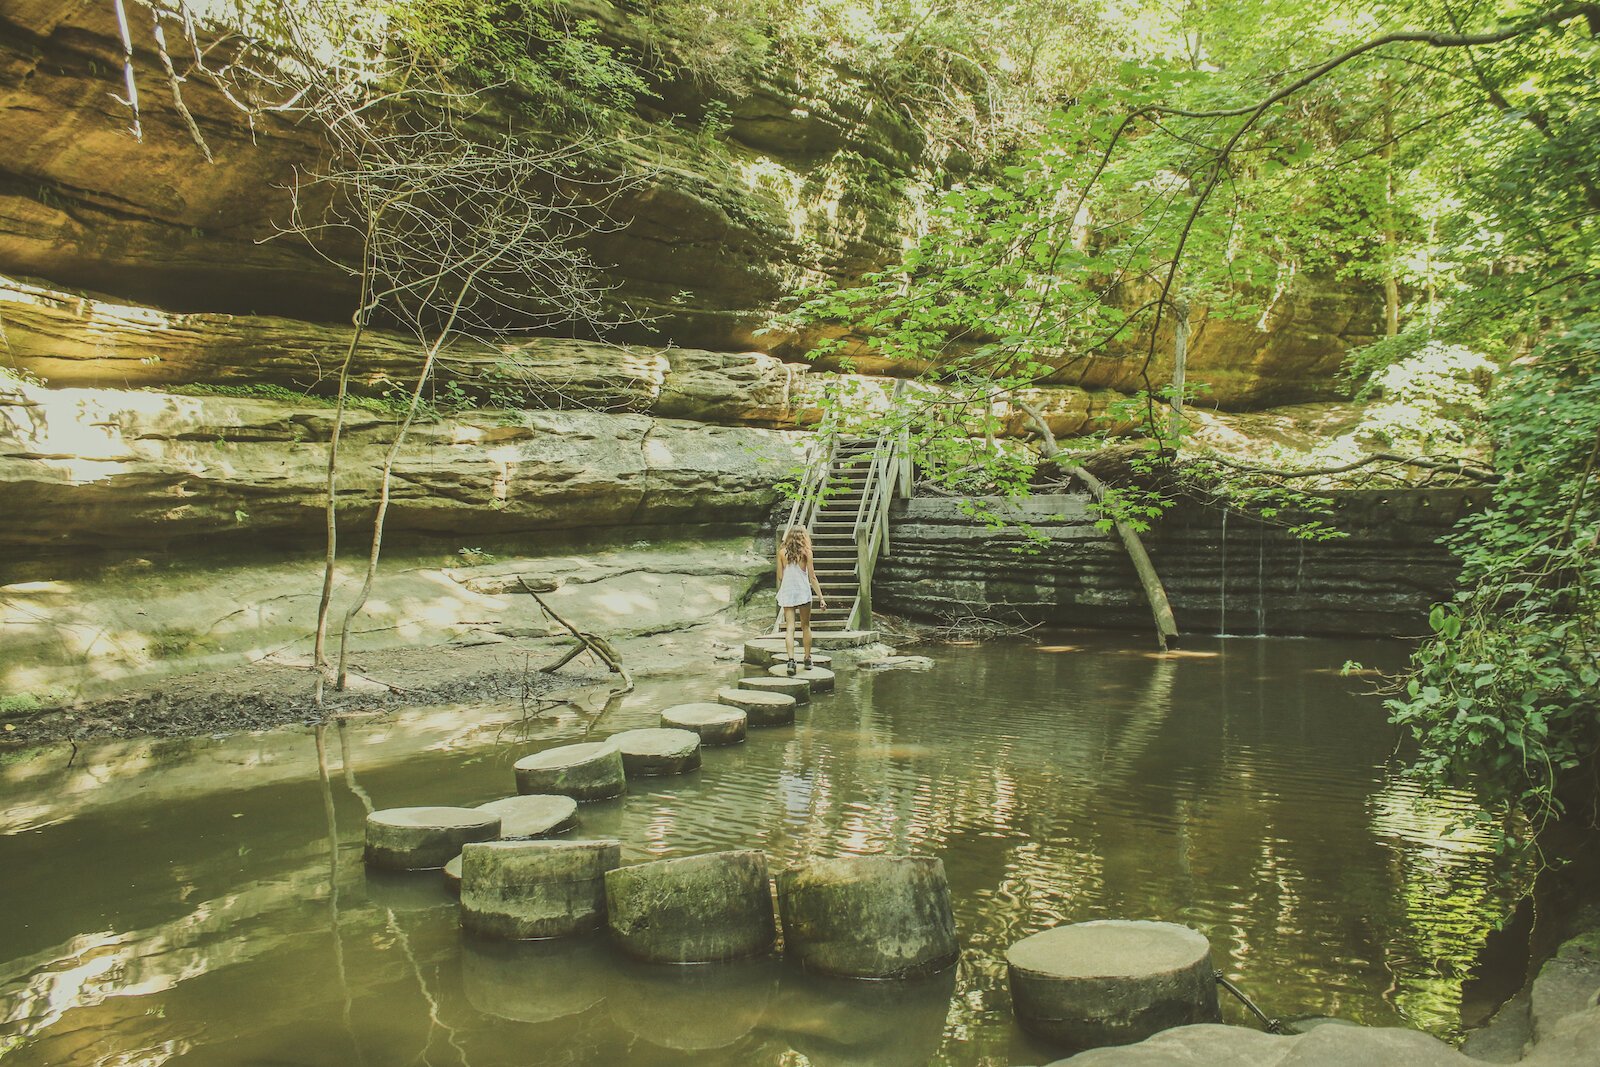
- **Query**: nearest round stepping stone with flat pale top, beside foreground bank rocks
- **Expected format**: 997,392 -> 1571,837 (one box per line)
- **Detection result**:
1005,920 -> 1222,1049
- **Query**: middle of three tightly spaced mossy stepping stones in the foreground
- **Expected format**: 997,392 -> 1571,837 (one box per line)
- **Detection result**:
605,851 -> 778,963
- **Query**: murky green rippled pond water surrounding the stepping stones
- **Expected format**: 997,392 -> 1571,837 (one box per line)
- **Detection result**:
0,637 -> 1512,1067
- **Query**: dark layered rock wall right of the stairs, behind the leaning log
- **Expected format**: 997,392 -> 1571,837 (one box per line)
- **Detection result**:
874,490 -> 1486,635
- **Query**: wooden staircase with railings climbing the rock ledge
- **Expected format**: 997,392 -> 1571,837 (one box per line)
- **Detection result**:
779,437 -> 910,632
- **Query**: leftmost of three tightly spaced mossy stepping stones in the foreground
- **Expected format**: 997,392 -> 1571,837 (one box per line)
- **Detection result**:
461,840 -> 622,941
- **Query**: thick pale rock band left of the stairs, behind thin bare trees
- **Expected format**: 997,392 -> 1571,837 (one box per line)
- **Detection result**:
0,377 -> 797,545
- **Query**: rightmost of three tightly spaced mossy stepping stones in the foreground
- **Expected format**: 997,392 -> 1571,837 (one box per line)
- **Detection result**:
778,856 -> 960,977
